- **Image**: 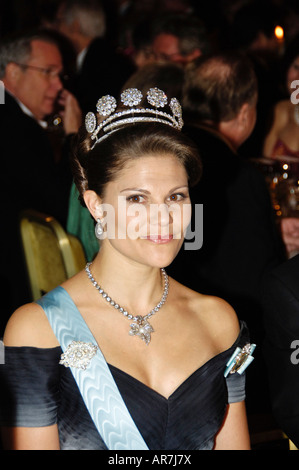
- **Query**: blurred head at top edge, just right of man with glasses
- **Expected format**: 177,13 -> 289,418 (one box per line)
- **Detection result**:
57,0 -> 106,53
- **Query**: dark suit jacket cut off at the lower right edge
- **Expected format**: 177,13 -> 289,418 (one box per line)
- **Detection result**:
263,255 -> 299,447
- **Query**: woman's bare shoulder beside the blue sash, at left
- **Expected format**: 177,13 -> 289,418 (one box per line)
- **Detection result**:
3,302 -> 59,348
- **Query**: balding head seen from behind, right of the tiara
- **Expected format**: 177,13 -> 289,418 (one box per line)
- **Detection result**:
183,54 -> 258,148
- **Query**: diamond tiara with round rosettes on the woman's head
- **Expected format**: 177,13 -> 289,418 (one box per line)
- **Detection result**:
85,87 -> 184,147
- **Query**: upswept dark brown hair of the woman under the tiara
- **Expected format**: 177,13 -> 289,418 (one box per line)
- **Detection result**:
71,123 -> 201,206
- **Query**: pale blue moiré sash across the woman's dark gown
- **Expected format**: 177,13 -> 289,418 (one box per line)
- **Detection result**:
36,287 -> 148,450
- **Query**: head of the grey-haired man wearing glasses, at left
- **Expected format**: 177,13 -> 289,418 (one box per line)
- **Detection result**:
0,31 -> 63,119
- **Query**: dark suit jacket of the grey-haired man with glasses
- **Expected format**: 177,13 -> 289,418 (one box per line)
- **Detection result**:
0,94 -> 71,326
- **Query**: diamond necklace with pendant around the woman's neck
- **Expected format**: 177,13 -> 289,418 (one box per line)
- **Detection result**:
85,263 -> 169,345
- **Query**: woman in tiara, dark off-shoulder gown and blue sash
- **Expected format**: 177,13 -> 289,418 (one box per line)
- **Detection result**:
1,89 -> 254,450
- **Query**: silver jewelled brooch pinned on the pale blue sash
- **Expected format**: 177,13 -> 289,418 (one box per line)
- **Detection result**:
59,341 -> 98,370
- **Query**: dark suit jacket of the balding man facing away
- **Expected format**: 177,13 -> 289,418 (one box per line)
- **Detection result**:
168,123 -> 284,341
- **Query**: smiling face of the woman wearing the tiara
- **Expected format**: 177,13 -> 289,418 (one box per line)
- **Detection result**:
101,155 -> 191,267
